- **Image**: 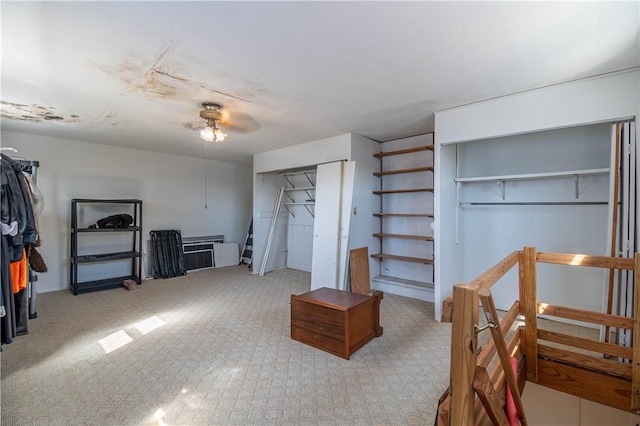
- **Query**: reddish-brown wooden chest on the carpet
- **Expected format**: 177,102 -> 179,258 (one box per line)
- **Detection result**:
291,288 -> 383,359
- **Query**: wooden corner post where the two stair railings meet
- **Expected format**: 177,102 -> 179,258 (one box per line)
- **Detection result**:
520,247 -> 538,383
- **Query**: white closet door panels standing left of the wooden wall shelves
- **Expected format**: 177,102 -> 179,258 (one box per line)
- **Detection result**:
311,161 -> 356,290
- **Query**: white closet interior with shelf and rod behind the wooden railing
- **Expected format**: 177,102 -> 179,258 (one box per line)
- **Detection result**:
454,123 -> 611,310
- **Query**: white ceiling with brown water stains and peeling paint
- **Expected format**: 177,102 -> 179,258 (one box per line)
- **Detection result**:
0,1 -> 640,163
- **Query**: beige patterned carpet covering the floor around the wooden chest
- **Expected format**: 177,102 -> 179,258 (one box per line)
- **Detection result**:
1,266 -> 450,425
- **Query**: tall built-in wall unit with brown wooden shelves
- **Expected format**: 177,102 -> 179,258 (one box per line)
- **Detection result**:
371,138 -> 434,300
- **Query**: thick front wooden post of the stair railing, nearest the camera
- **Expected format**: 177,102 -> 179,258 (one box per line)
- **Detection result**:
449,284 -> 479,426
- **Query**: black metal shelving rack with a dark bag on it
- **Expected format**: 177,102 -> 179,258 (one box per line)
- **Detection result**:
69,198 -> 142,295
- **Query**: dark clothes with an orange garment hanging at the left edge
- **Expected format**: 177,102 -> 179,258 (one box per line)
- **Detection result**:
0,154 -> 42,343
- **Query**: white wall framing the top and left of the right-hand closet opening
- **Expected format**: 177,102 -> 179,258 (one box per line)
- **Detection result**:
435,70 -> 640,320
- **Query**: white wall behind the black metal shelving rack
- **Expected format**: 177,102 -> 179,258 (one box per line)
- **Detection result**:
2,131 -> 252,292
